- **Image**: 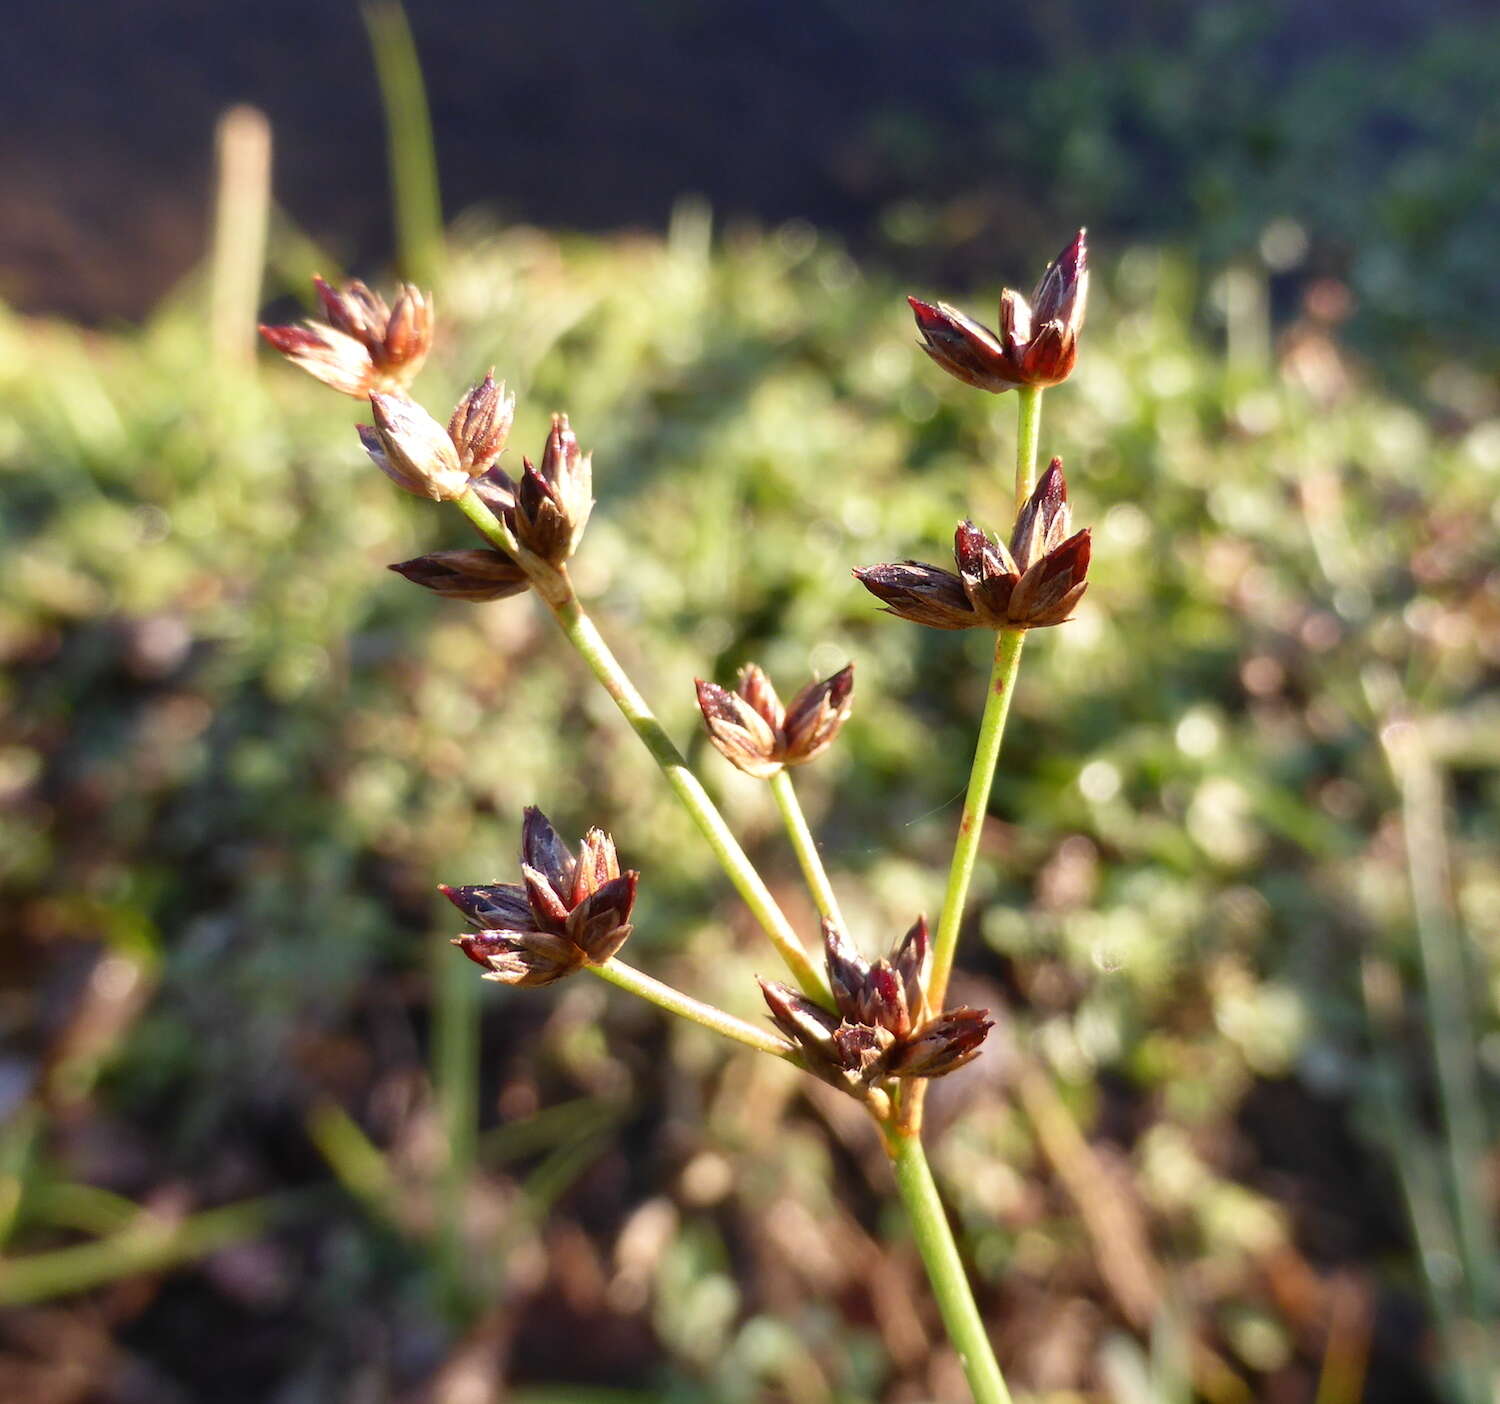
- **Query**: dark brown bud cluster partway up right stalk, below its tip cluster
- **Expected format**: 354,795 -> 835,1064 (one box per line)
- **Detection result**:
855,459 -> 1091,629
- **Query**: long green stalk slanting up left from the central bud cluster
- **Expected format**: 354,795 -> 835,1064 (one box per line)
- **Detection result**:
459,492 -> 833,1008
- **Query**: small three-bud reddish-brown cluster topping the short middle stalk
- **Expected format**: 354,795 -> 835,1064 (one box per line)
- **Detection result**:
698,663 -> 854,780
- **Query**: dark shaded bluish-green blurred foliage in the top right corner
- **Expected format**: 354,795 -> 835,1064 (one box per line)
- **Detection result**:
867,0 -> 1500,378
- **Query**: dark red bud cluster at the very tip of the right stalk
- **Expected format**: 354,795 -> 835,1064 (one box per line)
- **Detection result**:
908,230 -> 1089,395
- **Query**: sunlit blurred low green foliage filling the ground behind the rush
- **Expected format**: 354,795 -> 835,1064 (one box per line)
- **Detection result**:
0,211 -> 1500,1404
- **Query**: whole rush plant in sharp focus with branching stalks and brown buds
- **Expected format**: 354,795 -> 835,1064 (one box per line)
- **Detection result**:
261,231 -> 1091,1404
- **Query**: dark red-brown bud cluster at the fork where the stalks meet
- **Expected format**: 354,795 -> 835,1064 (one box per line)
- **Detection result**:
761,917 -> 995,1095
